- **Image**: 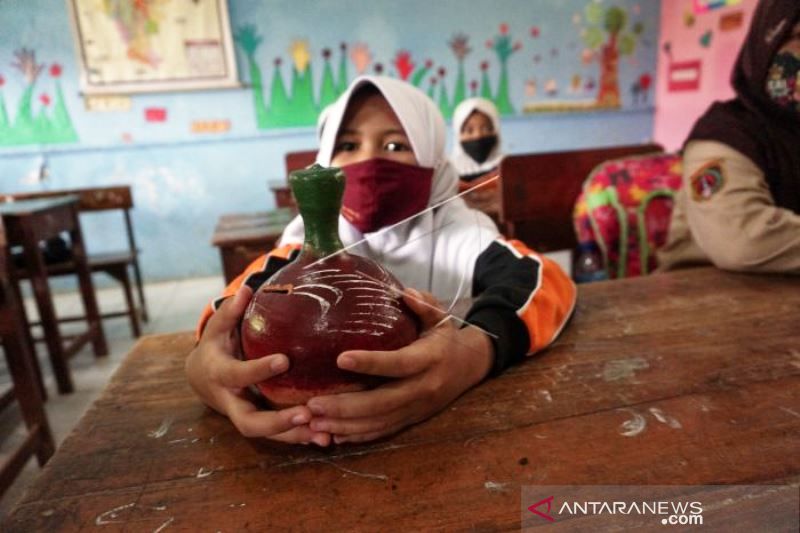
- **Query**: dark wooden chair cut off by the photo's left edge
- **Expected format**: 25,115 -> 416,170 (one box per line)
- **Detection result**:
0,215 -> 55,496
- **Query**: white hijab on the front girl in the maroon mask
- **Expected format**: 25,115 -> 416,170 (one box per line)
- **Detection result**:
280,76 -> 499,304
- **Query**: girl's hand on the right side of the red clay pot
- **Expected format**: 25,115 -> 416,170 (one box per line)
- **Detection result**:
308,290 -> 493,443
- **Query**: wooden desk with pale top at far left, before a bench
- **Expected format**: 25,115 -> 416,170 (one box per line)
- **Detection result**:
0,195 -> 108,393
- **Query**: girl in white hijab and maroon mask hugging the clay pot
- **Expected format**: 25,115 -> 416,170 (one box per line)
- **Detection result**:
186,76 -> 576,446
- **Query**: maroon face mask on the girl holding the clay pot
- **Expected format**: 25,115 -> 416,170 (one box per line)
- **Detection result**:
342,158 -> 433,233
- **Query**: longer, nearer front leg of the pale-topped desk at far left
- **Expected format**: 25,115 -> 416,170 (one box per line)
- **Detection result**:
21,218 -> 75,394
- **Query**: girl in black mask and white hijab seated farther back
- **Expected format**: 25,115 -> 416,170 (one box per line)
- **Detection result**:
450,98 -> 503,216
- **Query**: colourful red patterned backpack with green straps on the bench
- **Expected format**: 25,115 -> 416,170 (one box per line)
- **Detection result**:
573,154 -> 681,279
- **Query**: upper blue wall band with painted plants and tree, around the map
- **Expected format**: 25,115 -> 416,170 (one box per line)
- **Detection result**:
0,0 -> 656,149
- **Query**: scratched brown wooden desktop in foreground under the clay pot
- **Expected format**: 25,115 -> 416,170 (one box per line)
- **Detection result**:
0,269 -> 800,531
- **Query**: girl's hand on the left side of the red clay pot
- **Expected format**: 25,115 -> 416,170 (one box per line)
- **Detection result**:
186,287 -> 330,446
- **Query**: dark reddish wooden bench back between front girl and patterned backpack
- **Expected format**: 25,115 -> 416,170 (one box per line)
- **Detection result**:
499,144 -> 663,252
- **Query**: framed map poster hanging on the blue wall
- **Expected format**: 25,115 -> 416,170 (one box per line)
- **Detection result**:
67,0 -> 240,95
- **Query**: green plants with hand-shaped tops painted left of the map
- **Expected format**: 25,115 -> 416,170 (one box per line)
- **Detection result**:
0,48 -> 78,145
